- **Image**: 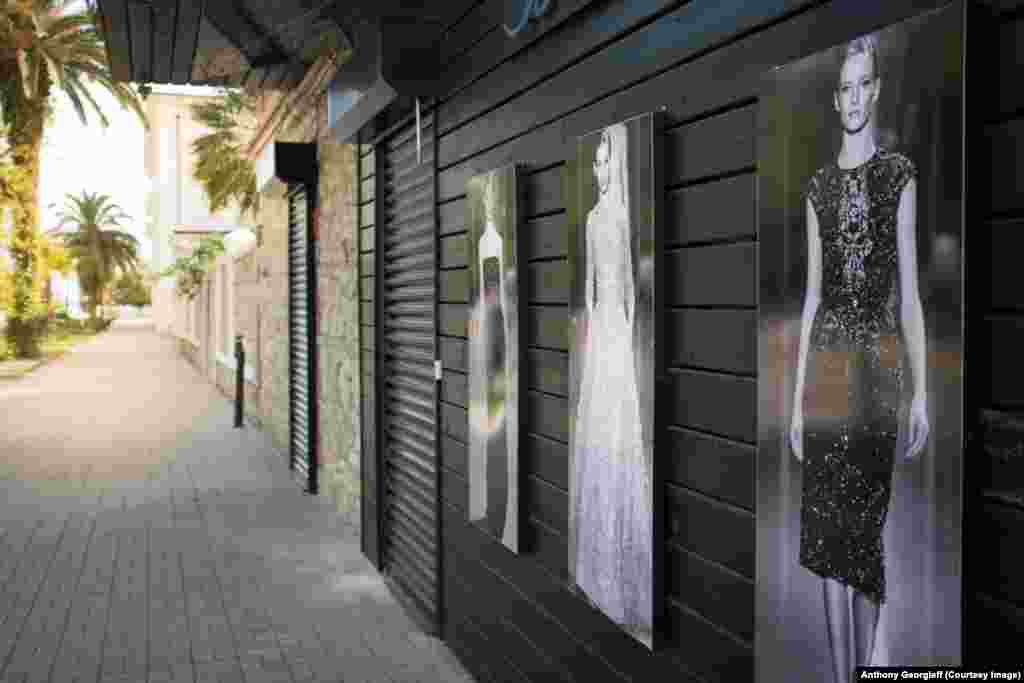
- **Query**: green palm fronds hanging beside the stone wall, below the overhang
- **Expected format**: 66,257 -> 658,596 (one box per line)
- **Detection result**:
191,90 -> 260,219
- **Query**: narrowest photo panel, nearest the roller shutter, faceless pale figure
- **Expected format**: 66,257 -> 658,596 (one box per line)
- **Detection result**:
466,165 -> 522,553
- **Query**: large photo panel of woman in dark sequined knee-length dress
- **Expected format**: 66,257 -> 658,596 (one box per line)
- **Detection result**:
756,3 -> 965,683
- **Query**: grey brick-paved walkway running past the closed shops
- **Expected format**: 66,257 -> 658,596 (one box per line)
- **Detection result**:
0,321 -> 472,683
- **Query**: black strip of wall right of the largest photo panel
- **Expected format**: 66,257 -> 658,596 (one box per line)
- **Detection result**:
965,0 -> 1024,665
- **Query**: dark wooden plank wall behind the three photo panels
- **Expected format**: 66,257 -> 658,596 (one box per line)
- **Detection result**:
360,0 -> 1024,683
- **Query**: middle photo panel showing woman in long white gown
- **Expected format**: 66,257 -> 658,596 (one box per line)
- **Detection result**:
566,115 -> 662,648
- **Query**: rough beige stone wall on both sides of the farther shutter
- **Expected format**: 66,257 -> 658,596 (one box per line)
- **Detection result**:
232,94 -> 360,532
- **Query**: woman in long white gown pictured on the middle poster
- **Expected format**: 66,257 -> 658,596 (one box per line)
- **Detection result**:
571,124 -> 653,645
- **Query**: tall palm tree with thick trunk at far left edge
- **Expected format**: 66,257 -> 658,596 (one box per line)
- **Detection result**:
0,0 -> 145,356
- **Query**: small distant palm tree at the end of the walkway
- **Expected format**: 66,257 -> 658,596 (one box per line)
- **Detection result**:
60,191 -> 138,321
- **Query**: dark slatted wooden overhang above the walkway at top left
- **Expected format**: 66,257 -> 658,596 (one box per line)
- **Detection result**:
98,0 -> 473,90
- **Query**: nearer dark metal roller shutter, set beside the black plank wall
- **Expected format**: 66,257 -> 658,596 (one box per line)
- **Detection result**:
376,114 -> 439,630
